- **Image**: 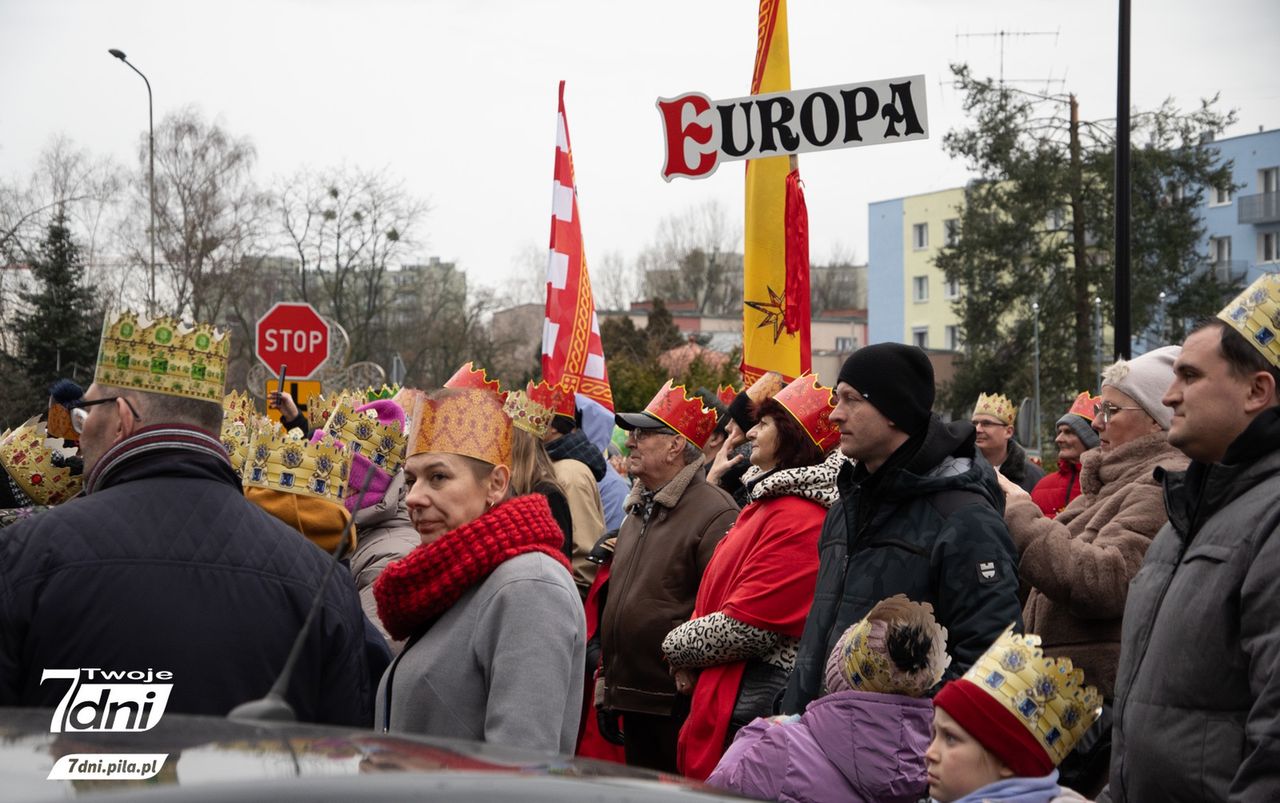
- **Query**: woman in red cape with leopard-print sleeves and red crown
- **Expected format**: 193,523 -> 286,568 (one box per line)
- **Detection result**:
663,377 -> 844,780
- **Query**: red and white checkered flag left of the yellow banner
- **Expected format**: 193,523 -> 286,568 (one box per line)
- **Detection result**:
543,81 -> 613,412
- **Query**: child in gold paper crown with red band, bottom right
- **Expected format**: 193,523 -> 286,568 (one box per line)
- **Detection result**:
924,628 -> 1102,803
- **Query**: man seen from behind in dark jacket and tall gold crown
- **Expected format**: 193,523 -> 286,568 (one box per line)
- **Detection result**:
0,314 -> 372,725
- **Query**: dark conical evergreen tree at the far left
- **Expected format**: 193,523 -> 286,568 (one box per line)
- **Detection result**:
18,210 -> 102,406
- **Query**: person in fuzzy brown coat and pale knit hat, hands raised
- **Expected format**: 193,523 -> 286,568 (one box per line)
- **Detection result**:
1000,346 -> 1188,794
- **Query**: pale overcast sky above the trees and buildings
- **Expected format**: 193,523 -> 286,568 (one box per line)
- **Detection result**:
0,0 -> 1280,297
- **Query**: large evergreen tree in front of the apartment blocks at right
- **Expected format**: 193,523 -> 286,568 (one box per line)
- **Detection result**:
937,65 -> 1236,435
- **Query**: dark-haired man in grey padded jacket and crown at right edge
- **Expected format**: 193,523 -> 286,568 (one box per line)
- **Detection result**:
1100,274 -> 1280,803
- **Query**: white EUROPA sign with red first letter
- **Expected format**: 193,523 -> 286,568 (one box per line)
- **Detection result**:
658,76 -> 929,181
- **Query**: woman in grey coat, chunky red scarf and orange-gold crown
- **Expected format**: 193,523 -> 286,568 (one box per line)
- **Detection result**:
374,387 -> 586,753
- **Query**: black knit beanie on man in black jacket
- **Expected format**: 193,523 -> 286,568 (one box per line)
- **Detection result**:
838,343 -> 934,435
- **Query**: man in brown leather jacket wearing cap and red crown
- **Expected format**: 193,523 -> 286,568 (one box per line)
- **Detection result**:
595,382 -> 737,772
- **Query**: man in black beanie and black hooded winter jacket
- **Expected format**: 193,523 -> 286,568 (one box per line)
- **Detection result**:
782,343 -> 1021,713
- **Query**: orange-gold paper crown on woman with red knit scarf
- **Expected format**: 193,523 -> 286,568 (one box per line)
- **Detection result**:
408,388 -> 511,466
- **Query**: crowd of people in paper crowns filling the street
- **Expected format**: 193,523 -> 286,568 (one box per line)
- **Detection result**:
0,275 -> 1280,803
